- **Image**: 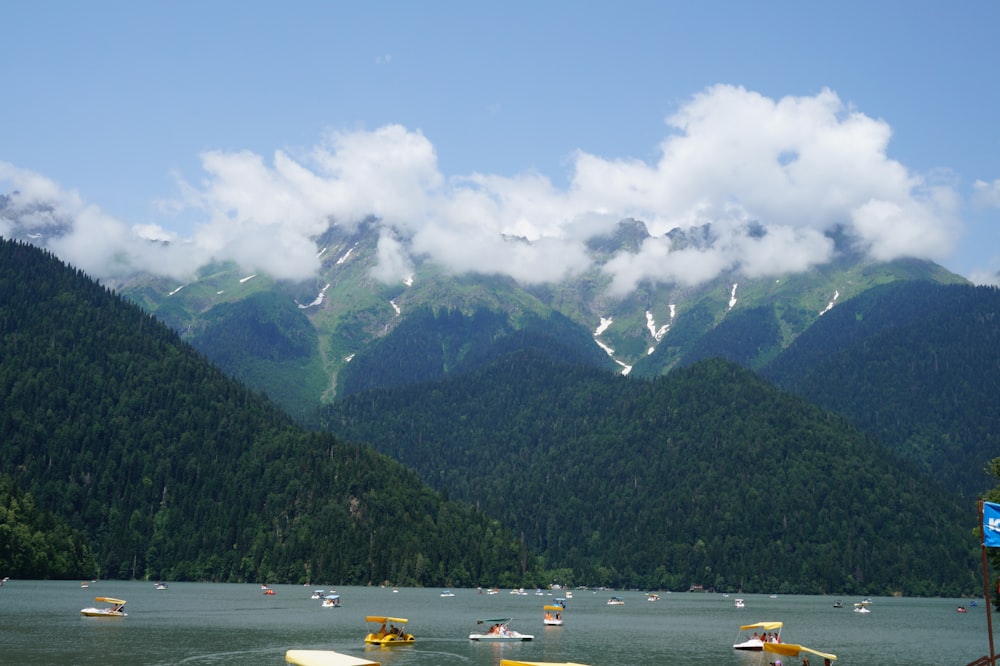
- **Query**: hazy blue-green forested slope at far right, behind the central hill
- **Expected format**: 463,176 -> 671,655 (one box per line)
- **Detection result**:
762,281 -> 1000,497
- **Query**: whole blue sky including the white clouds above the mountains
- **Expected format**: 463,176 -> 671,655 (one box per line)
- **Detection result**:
0,0 -> 1000,292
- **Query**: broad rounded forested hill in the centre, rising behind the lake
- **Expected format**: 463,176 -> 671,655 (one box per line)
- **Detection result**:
326,352 -> 986,594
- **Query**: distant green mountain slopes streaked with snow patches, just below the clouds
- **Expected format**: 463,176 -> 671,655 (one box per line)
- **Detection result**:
105,220 -> 964,419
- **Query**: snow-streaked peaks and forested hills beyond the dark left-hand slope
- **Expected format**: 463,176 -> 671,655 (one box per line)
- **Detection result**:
1,206 -> 1000,594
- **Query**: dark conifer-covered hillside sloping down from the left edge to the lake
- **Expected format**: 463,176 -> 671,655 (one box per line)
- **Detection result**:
0,240 -> 530,586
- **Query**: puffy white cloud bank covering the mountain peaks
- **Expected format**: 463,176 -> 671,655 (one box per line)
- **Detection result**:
0,85 -> 968,294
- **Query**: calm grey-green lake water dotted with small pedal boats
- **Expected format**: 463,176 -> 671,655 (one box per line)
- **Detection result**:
0,580 -> 1000,666
